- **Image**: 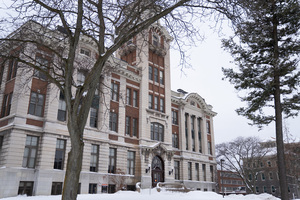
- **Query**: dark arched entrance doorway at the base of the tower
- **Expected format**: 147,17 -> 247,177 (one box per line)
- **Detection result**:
151,156 -> 164,187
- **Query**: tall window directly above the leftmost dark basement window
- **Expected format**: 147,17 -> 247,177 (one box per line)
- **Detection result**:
22,135 -> 39,168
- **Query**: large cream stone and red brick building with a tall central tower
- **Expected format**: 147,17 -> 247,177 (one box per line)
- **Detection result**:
0,23 -> 216,198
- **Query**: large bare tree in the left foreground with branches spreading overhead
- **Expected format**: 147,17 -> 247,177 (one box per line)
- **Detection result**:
0,0 -> 232,200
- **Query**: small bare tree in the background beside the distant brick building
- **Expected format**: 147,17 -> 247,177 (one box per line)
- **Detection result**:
216,137 -> 270,193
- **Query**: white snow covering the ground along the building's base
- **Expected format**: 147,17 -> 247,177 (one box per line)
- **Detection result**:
1,190 -> 290,200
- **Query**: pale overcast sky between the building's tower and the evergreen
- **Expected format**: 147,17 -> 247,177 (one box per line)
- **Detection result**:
171,21 -> 300,144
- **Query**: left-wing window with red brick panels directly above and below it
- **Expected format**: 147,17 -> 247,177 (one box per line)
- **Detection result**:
28,92 -> 45,117
